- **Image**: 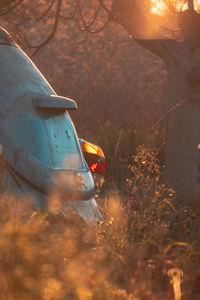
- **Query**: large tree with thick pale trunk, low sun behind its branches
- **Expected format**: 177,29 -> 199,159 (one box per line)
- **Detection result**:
112,0 -> 200,203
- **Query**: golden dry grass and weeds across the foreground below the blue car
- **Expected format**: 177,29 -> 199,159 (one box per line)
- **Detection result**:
0,146 -> 200,300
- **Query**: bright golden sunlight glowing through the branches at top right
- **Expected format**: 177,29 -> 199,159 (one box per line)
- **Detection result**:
151,0 -> 200,16
